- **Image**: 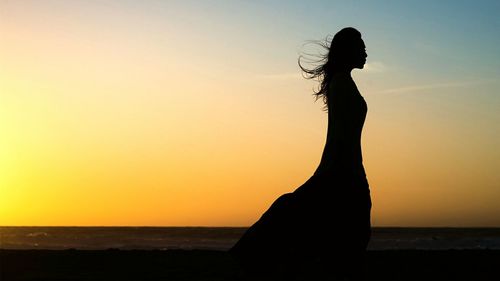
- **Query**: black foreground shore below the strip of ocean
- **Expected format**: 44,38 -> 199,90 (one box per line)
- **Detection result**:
0,250 -> 500,281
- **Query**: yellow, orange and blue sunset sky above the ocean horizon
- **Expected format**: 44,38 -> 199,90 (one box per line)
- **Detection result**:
0,0 -> 500,227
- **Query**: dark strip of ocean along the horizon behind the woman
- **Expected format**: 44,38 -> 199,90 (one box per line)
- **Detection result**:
0,226 -> 500,251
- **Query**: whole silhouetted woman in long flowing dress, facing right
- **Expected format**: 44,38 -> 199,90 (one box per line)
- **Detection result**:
230,27 -> 371,280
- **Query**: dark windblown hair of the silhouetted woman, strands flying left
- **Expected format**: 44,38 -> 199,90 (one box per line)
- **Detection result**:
298,27 -> 361,109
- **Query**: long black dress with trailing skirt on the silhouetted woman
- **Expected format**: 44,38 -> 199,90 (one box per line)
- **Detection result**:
230,74 -> 371,275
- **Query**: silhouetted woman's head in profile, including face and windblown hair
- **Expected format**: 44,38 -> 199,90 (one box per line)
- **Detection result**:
299,27 -> 367,104
